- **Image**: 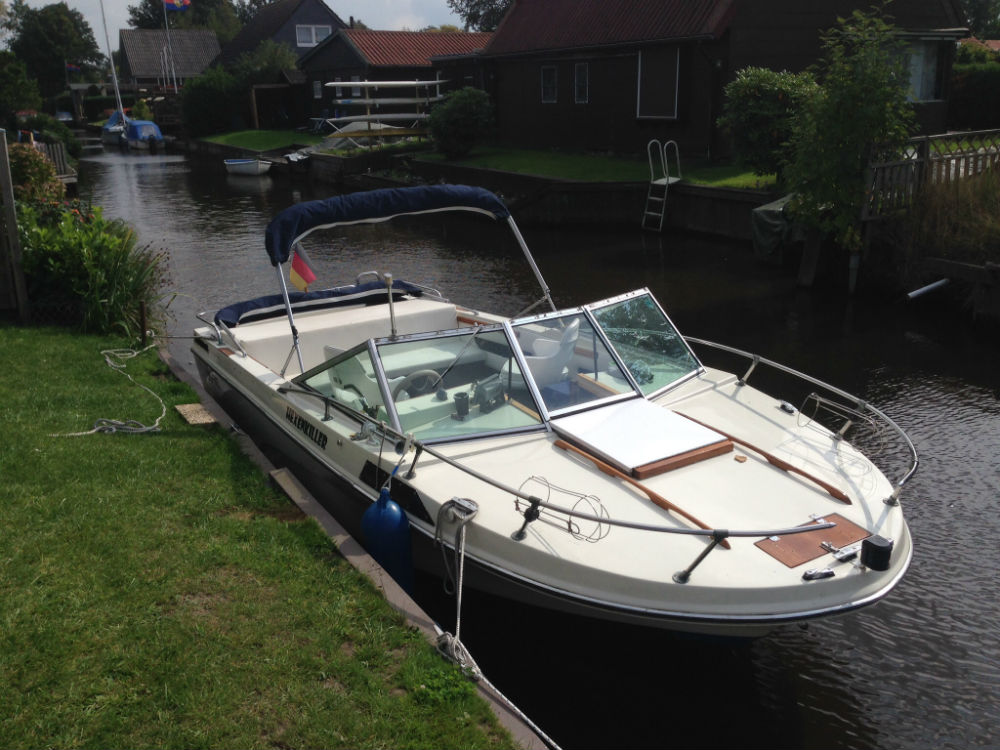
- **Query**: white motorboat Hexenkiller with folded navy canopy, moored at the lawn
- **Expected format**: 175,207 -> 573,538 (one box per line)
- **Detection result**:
192,186 -> 917,636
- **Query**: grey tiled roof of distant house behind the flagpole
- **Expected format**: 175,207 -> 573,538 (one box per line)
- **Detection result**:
118,29 -> 219,78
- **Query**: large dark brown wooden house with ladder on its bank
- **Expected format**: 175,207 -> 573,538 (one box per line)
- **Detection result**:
479,0 -> 967,155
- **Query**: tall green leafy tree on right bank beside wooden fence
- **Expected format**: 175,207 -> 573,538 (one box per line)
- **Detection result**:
787,8 -> 915,252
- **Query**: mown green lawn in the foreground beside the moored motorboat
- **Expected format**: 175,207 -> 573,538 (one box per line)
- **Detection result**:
0,325 -> 512,748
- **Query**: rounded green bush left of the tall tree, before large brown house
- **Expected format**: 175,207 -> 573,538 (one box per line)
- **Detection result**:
719,67 -> 818,182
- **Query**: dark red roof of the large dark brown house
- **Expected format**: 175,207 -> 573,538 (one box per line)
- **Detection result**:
485,0 -> 735,55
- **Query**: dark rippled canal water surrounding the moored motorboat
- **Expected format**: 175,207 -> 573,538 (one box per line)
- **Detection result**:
80,151 -> 1000,750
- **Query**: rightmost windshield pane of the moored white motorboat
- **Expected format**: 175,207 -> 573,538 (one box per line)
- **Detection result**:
588,292 -> 700,396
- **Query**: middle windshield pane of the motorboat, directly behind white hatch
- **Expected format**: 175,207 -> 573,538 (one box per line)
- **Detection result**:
513,312 -> 635,412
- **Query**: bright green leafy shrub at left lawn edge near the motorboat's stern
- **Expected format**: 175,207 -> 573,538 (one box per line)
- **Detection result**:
18,202 -> 166,337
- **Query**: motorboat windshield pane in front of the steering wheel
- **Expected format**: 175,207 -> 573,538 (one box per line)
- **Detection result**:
376,328 -> 542,440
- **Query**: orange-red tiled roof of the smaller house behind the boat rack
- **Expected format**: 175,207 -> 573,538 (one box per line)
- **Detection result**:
340,29 -> 493,67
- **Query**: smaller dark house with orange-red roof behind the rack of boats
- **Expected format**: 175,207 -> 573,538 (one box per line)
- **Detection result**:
299,29 -> 492,122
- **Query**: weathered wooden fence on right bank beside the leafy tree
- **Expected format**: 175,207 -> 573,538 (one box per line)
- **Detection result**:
861,130 -> 1000,221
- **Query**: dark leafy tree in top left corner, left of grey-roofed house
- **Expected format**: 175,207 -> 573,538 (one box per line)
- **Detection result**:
10,0 -> 104,96
